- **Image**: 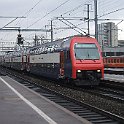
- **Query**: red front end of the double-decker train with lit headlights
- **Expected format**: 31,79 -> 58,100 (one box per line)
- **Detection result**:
70,37 -> 104,85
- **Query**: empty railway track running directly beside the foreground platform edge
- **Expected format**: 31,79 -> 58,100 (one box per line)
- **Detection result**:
0,66 -> 124,124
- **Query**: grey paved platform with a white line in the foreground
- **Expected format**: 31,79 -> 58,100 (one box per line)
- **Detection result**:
0,76 -> 91,124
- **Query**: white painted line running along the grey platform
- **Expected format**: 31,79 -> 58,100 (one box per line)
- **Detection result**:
0,77 -> 57,124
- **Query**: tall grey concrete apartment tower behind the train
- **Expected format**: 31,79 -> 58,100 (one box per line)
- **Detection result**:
98,22 -> 118,47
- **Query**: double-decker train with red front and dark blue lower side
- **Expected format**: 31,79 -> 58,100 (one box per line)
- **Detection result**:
1,36 -> 104,86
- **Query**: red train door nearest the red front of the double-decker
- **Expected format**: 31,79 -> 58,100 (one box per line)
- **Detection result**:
60,51 -> 64,78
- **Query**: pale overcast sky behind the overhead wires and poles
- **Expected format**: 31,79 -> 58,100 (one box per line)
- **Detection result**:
0,0 -> 124,46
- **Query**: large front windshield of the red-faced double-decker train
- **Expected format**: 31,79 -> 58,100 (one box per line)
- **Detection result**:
74,43 -> 100,60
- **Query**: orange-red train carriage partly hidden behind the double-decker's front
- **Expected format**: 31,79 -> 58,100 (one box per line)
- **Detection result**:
103,55 -> 124,68
